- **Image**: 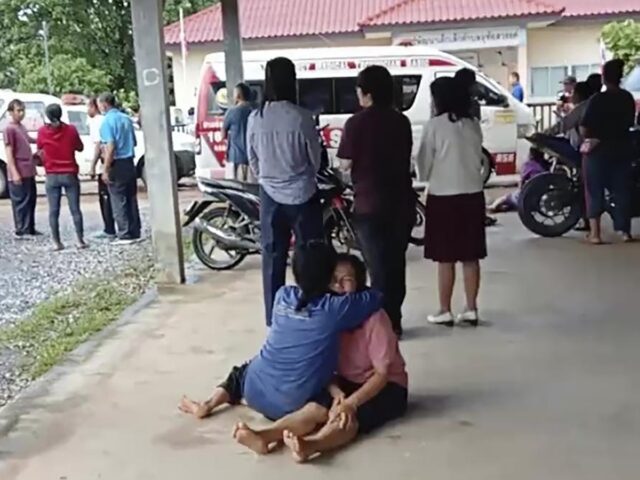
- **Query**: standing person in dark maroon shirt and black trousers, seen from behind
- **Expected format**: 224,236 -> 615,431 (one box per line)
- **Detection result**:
338,66 -> 417,335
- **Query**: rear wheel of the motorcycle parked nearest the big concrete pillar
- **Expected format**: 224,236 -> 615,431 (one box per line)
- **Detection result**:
191,207 -> 247,270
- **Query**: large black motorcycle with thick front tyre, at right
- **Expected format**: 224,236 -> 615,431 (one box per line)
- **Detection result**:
518,131 -> 640,237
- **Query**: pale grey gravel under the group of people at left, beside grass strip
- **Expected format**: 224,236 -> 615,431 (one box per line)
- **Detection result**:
0,202 -> 152,406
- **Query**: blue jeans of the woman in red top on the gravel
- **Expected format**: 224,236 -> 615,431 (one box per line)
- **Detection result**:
46,174 -> 84,242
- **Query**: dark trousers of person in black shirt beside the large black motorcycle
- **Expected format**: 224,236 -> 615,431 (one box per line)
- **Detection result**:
583,148 -> 632,233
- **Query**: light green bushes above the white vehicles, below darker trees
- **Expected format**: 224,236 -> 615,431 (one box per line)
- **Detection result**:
19,54 -> 111,96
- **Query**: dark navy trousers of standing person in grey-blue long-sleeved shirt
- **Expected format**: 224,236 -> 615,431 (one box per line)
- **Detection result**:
260,188 -> 324,326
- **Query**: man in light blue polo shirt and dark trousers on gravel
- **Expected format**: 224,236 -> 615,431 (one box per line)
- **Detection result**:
98,93 -> 140,245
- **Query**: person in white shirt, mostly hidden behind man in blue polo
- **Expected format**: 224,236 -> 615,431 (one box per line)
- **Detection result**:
87,97 -> 116,239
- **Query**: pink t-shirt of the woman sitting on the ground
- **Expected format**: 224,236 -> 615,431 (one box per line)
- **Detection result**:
338,310 -> 409,387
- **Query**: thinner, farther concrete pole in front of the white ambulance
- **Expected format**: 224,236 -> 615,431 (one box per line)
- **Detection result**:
221,0 -> 244,96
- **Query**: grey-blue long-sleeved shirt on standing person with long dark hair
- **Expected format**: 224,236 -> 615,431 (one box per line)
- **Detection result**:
247,101 -> 320,205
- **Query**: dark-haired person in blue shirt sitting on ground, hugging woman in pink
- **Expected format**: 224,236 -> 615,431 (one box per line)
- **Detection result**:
180,242 -> 382,446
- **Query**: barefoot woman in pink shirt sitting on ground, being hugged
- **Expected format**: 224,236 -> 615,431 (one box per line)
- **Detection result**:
180,254 -> 408,462
